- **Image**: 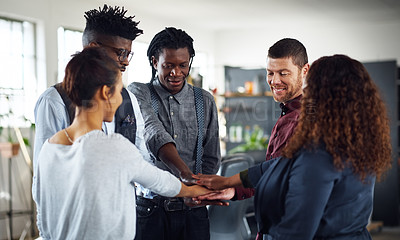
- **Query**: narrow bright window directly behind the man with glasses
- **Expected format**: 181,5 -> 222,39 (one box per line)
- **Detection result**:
57,27 -> 83,82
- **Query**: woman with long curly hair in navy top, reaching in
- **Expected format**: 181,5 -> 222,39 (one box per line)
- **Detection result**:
198,55 -> 391,240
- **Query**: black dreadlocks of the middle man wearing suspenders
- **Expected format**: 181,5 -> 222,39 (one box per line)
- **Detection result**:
147,27 -> 195,81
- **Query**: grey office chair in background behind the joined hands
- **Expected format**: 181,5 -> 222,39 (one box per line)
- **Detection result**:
208,154 -> 254,240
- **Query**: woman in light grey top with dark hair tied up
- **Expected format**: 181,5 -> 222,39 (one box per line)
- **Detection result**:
33,47 -> 209,239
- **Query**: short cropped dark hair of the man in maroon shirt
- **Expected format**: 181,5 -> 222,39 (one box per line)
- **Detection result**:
268,38 -> 308,69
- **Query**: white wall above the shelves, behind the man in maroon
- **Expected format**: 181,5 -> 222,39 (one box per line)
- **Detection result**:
215,21 -> 400,67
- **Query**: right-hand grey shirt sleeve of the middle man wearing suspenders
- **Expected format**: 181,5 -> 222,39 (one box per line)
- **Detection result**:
203,90 -> 221,174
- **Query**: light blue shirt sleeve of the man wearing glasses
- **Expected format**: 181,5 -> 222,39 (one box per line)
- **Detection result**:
33,87 -> 70,171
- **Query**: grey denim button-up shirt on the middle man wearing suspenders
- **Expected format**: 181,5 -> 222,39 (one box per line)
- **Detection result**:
128,79 -> 221,178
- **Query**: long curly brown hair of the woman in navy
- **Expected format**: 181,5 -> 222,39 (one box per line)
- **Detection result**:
282,55 -> 392,180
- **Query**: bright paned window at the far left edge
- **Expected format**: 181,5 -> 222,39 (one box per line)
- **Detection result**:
0,17 -> 38,126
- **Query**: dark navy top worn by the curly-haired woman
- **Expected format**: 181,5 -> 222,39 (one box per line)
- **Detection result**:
248,149 -> 375,240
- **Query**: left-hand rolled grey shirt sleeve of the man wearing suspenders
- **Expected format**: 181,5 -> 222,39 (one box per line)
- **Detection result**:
128,83 -> 175,157
